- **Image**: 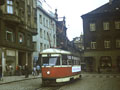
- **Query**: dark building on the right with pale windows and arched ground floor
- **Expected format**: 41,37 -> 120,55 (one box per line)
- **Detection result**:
82,0 -> 120,72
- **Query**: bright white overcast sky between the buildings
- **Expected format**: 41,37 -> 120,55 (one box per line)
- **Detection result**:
44,0 -> 109,40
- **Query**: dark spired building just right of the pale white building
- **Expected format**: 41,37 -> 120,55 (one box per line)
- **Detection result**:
55,9 -> 68,50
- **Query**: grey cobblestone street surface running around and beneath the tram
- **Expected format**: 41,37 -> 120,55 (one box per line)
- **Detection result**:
0,74 -> 120,90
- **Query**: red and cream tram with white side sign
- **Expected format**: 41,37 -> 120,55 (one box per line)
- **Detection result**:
41,48 -> 81,85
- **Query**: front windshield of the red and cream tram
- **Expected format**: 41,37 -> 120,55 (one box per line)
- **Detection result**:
42,57 -> 60,66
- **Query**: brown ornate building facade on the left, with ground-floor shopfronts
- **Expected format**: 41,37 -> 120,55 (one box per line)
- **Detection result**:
0,0 -> 37,75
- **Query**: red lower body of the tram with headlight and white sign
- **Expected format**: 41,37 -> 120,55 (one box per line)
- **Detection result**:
42,66 -> 81,82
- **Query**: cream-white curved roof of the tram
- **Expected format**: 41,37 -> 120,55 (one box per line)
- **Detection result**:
40,48 -> 71,54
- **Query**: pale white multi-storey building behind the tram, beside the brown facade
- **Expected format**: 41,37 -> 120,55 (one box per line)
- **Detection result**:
33,0 -> 56,64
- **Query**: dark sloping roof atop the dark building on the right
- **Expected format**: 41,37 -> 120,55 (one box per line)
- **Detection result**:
83,0 -> 120,16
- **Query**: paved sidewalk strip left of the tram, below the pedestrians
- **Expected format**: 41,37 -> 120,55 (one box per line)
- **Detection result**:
0,73 -> 41,85
